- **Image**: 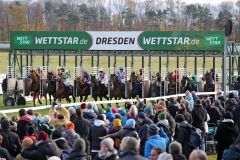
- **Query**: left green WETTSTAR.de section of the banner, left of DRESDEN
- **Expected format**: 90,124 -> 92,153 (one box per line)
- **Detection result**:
10,31 -> 92,50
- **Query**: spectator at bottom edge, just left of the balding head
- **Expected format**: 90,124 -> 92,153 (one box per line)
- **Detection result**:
169,141 -> 187,160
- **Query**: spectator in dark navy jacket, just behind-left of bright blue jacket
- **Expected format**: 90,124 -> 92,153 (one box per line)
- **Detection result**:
136,112 -> 153,155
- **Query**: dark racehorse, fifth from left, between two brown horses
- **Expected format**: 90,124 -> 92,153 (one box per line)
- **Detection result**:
91,75 -> 109,101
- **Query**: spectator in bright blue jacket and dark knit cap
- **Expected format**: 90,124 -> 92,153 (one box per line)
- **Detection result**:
144,124 -> 168,160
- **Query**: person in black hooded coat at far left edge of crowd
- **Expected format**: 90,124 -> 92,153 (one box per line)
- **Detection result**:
1,119 -> 21,157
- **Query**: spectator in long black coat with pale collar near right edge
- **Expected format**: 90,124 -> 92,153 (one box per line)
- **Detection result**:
214,112 -> 239,160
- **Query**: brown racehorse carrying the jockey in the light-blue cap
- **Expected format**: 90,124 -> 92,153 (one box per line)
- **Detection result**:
108,74 -> 125,100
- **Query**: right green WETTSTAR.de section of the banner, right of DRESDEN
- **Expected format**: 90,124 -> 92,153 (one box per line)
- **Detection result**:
138,31 -> 224,51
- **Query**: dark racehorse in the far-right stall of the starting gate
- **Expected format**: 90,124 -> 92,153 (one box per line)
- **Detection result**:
202,72 -> 215,92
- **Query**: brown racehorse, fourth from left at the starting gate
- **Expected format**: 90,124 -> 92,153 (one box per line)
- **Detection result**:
74,77 -> 91,102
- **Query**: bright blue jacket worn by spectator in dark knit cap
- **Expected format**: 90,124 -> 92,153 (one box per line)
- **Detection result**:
144,135 -> 168,159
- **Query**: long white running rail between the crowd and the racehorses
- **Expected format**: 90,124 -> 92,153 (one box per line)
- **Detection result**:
0,91 -> 233,113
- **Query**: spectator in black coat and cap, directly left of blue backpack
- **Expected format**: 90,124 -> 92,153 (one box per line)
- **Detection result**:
175,114 -> 194,158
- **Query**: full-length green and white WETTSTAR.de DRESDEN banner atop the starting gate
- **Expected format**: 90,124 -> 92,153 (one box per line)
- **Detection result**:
10,31 -> 224,51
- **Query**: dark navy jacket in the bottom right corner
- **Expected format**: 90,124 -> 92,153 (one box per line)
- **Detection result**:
223,145 -> 240,160
